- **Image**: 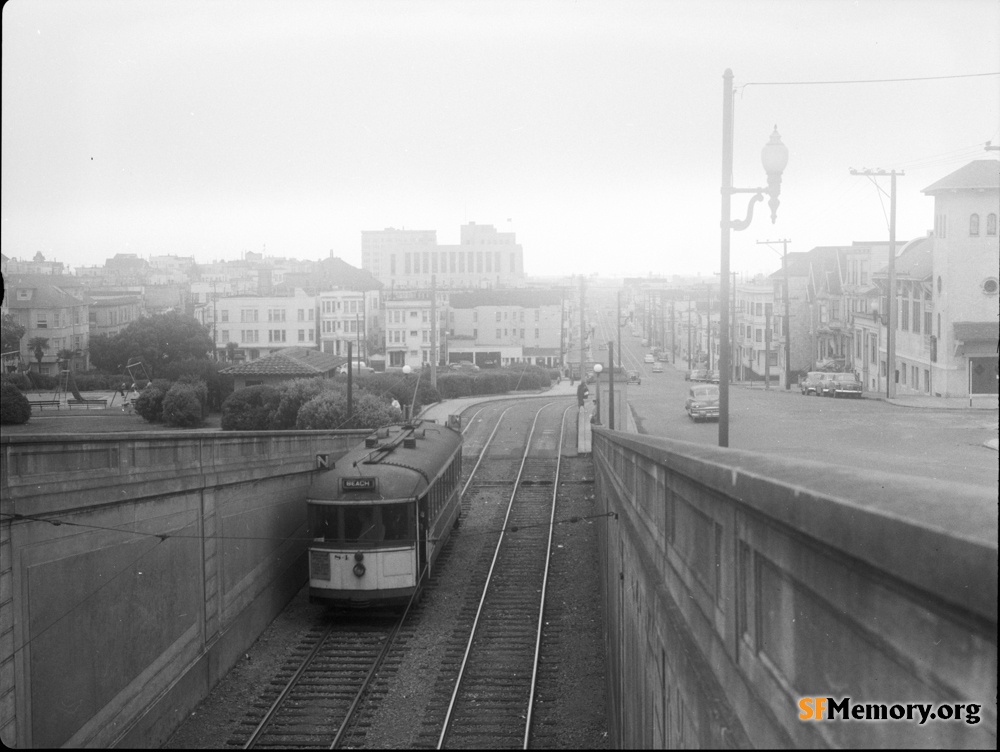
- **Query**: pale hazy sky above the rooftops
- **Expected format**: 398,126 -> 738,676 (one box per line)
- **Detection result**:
0,0 -> 1000,275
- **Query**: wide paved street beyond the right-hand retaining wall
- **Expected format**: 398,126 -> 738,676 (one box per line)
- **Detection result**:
597,312 -> 998,489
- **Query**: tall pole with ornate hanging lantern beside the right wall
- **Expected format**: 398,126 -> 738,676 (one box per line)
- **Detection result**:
719,68 -> 788,447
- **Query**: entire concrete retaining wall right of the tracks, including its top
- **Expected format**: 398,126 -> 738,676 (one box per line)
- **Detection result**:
593,428 -> 997,749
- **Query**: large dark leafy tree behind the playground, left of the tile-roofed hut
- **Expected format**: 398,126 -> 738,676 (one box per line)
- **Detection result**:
90,313 -> 212,376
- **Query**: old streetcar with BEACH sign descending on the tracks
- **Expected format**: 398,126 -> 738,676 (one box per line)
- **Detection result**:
306,415 -> 462,609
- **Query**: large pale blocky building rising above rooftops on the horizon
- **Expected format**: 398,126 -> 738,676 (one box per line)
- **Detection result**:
361,222 -> 524,289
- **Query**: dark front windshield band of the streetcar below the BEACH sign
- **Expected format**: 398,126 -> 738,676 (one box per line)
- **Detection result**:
309,504 -> 415,546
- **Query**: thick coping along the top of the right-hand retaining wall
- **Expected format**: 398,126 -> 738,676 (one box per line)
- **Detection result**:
593,427 -> 998,625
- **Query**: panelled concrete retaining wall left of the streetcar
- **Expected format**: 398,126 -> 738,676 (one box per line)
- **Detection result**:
0,431 -> 364,748
